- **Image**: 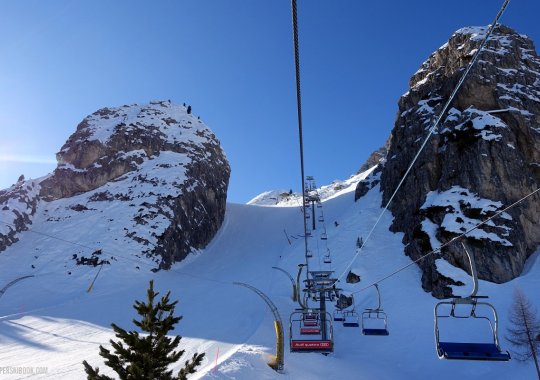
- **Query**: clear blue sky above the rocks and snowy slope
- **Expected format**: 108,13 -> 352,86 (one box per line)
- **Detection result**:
0,0 -> 540,203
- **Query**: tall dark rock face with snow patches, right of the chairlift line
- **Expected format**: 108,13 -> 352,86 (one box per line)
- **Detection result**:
362,26 -> 540,297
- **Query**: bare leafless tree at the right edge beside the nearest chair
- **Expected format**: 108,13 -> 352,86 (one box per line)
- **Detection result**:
506,289 -> 540,379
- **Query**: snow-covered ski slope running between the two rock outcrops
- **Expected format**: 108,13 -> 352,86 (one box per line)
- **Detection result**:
0,176 -> 540,380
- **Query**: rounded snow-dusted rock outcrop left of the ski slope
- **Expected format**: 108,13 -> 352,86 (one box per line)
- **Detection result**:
0,102 -> 230,268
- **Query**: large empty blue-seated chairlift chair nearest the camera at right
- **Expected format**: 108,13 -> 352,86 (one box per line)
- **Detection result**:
434,243 -> 510,361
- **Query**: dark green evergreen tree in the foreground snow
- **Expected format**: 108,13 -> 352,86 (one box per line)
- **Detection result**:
83,281 -> 204,380
